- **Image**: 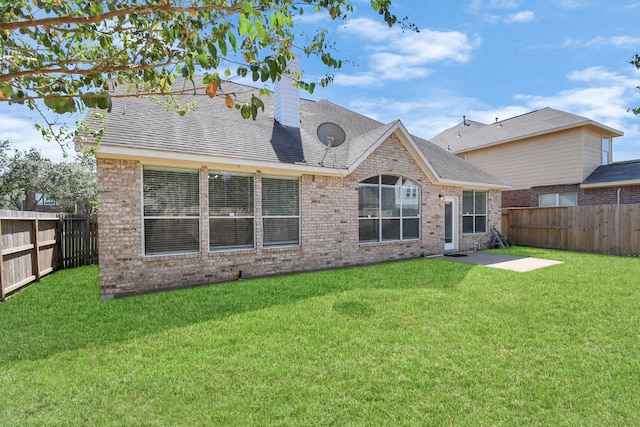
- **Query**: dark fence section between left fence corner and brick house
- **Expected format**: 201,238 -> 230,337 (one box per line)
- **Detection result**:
60,215 -> 98,268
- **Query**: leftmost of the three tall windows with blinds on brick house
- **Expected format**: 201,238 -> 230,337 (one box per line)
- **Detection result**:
142,167 -> 200,255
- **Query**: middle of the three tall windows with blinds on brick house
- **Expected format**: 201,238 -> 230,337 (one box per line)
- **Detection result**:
209,172 -> 254,250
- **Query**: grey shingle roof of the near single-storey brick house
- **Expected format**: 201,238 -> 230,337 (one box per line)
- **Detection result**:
80,79 -> 508,188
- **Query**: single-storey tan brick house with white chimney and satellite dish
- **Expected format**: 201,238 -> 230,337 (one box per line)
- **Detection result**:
82,68 -> 508,299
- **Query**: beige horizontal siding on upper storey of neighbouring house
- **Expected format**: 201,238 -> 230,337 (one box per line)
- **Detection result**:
466,129 -> 588,190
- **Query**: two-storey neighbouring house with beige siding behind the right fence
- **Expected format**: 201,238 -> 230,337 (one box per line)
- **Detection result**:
431,108 -> 624,207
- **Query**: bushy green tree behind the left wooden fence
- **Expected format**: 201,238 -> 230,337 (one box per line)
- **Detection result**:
0,141 -> 97,213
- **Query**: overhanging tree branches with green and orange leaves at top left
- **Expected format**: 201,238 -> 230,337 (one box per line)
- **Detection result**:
0,0 -> 415,152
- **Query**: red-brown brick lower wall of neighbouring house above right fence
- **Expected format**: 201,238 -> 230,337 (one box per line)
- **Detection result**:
502,184 -> 640,208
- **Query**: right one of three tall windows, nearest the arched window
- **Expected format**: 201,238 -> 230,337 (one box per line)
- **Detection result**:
262,177 -> 300,246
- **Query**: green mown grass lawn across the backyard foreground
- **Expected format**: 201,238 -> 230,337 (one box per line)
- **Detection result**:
0,248 -> 640,426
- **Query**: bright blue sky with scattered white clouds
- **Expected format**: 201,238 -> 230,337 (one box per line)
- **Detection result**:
0,0 -> 640,161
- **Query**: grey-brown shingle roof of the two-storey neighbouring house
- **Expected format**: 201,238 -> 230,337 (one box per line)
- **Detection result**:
431,107 -> 623,154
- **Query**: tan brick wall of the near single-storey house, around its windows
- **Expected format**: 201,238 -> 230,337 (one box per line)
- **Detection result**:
98,136 -> 501,298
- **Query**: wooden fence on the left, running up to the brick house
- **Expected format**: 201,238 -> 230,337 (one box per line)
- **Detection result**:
0,211 -> 98,301
